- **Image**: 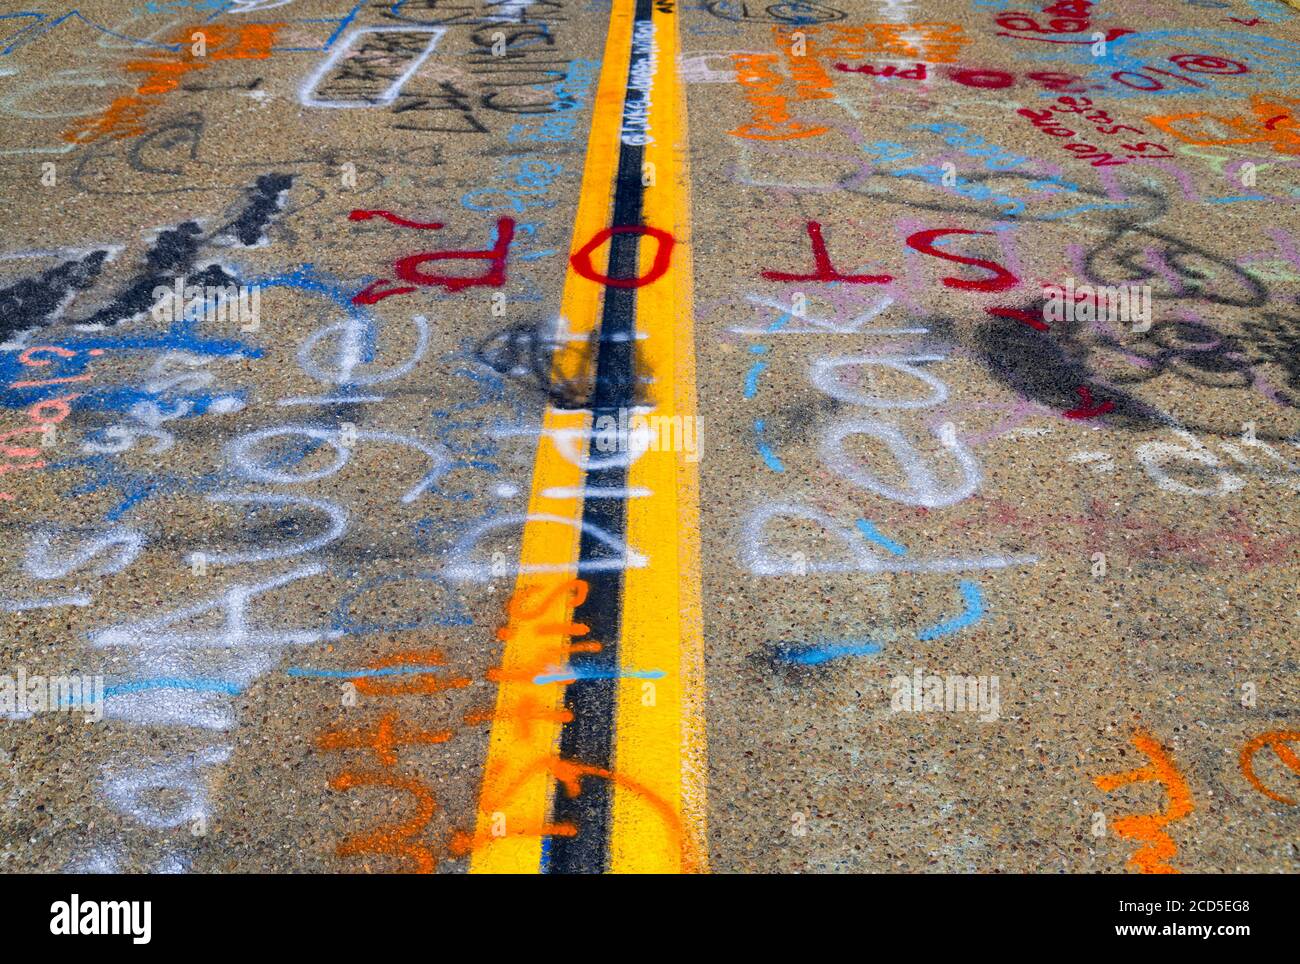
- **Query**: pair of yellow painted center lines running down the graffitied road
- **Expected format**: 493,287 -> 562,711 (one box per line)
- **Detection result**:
471,0 -> 707,873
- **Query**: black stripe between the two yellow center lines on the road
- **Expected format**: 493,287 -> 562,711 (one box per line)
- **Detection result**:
542,0 -> 653,873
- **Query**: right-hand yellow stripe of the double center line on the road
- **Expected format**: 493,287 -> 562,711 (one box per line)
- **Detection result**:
610,0 -> 707,873
